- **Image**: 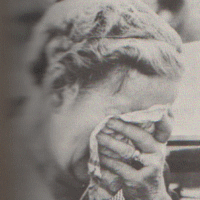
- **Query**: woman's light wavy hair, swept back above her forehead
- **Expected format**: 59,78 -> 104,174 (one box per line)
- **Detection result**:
30,0 -> 183,89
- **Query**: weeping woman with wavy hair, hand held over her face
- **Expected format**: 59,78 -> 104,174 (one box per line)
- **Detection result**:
29,0 -> 183,200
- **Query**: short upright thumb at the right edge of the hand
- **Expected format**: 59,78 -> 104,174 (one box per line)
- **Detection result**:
154,112 -> 174,143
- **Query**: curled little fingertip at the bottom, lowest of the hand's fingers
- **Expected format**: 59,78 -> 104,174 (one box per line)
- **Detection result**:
100,169 -> 122,195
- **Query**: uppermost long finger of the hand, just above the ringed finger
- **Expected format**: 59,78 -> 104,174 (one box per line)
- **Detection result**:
106,119 -> 158,153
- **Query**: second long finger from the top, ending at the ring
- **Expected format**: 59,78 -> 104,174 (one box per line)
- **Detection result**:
97,133 -> 135,159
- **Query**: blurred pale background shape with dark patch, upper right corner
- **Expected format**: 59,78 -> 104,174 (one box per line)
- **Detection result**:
143,0 -> 200,42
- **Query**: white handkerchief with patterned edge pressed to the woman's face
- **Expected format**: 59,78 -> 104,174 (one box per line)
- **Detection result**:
82,105 -> 169,200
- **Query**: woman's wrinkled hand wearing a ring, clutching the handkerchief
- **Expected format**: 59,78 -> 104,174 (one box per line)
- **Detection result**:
97,117 -> 172,200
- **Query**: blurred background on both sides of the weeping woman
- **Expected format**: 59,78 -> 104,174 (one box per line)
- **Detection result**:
0,0 -> 200,200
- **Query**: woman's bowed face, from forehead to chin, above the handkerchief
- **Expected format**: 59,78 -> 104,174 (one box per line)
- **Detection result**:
51,70 -> 177,187
